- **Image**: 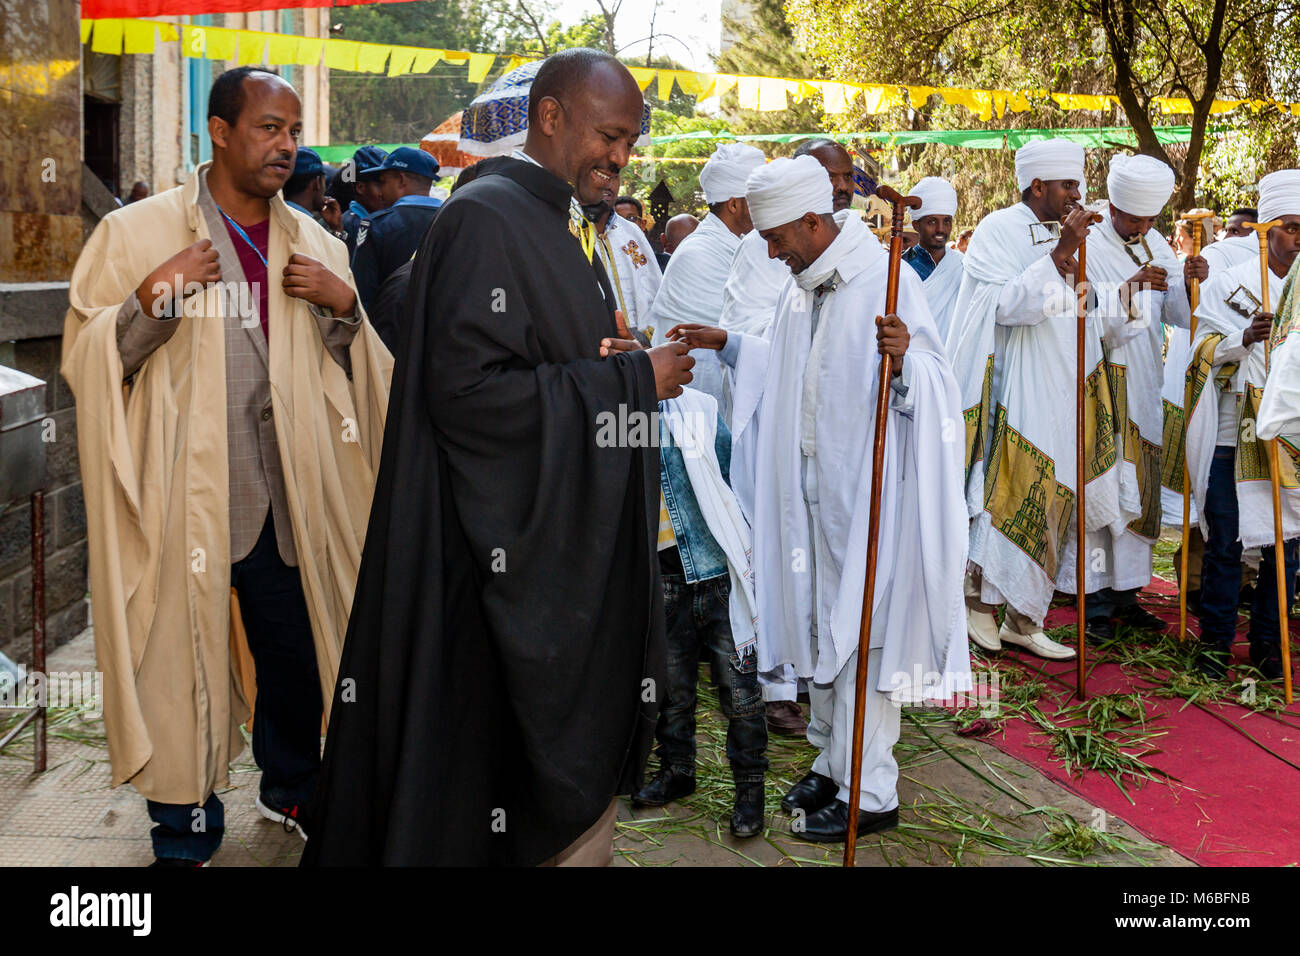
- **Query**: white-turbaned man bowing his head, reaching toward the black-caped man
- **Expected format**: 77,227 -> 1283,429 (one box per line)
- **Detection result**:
671,156 -> 970,842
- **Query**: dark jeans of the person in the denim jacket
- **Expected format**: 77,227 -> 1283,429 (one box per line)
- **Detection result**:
655,548 -> 767,783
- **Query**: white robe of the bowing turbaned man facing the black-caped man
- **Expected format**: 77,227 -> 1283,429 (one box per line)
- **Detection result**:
732,215 -> 970,701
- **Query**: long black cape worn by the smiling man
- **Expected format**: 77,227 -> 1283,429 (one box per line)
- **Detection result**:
303,157 -> 664,865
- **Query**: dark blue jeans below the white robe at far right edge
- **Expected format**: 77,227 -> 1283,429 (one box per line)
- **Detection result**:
1200,447 -> 1300,648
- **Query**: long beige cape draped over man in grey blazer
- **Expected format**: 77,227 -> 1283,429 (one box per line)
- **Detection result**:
62,166 -> 393,804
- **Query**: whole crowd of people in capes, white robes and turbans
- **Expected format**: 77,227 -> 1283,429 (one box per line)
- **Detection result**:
62,49 -> 1300,866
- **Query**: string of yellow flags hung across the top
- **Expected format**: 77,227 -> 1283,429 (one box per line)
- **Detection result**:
81,20 -> 1300,122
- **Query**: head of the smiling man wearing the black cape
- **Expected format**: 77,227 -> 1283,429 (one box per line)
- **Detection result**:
524,47 -> 645,207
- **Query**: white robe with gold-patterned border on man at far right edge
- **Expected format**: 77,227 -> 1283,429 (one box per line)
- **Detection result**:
1187,261 -> 1300,548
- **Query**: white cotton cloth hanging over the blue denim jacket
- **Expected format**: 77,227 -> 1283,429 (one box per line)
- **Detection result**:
659,388 -> 758,657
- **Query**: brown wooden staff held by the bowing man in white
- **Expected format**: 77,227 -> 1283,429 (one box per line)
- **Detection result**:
844,186 -> 922,866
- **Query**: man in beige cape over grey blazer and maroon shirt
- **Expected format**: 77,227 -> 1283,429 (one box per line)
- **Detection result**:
62,68 -> 393,865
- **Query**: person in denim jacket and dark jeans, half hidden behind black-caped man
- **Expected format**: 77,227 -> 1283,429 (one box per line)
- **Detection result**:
632,400 -> 767,838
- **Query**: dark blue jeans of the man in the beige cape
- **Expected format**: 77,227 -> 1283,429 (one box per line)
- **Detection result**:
150,509 -> 322,860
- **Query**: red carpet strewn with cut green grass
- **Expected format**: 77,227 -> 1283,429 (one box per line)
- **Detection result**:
984,579 -> 1300,866
